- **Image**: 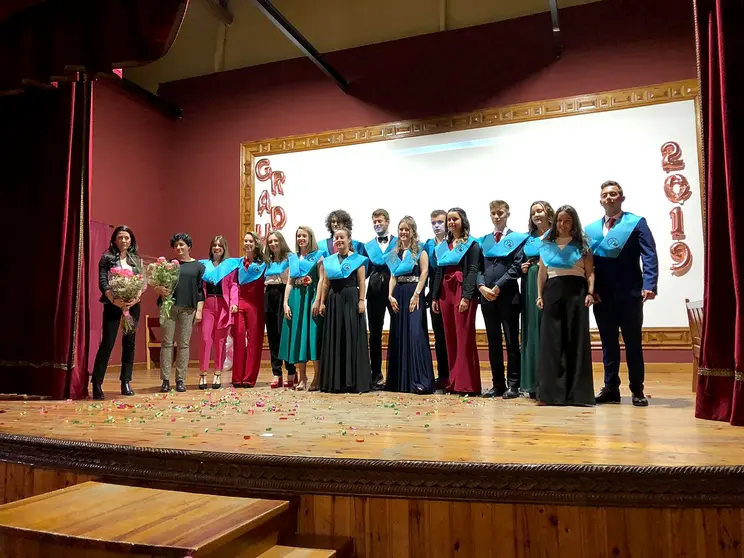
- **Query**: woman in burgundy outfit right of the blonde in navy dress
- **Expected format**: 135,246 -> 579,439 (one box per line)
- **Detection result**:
431,207 -> 481,395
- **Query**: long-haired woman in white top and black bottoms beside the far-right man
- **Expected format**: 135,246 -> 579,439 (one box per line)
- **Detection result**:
536,205 -> 594,406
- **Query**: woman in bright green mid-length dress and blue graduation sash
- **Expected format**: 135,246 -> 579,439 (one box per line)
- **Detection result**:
279,225 -> 325,390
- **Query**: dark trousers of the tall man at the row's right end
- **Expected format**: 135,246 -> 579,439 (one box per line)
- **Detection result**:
594,297 -> 646,393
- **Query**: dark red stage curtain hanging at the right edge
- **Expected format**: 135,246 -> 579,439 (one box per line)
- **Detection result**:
695,0 -> 744,426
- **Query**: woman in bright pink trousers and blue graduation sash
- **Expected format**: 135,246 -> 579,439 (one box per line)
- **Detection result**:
199,235 -> 241,389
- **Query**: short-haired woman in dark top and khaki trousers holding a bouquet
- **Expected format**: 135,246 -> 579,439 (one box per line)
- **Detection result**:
155,233 -> 205,393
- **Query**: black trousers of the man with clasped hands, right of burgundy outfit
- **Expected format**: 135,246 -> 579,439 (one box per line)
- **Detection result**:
481,297 -> 522,388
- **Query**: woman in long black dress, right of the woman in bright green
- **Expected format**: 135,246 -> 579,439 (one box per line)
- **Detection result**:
320,227 -> 372,393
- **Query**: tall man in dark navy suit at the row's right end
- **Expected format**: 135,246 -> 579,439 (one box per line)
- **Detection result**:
586,180 -> 659,407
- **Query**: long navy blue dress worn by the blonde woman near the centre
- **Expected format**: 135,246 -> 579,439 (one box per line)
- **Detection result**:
385,265 -> 434,394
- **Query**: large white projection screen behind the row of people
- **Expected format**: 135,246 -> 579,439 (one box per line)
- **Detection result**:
252,100 -> 703,328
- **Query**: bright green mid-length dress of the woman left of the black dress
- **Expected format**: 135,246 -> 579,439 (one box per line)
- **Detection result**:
279,256 -> 323,364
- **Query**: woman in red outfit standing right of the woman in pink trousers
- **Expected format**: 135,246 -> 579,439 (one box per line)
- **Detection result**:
233,232 -> 266,388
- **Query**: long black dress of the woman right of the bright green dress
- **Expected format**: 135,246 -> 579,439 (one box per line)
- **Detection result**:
320,272 -> 372,393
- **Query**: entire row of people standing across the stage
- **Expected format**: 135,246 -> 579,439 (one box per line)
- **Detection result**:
93,181 -> 658,406
